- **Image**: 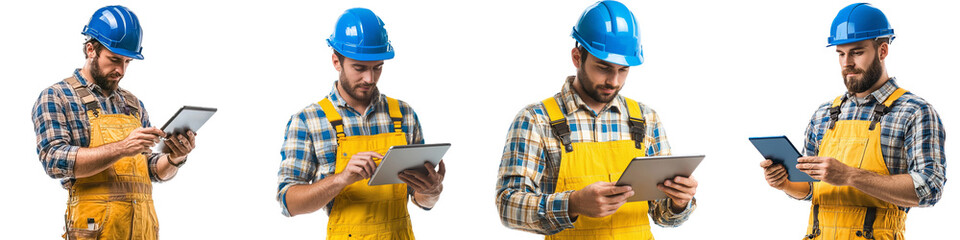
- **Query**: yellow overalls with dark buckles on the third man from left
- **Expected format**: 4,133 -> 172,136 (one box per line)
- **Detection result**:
543,97 -> 653,240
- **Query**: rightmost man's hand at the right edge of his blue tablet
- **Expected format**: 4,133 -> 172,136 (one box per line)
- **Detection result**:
797,157 -> 857,186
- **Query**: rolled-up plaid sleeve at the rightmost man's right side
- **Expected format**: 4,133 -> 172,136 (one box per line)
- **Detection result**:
904,105 -> 947,207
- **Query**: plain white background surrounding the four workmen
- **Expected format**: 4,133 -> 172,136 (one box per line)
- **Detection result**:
0,1 -> 960,239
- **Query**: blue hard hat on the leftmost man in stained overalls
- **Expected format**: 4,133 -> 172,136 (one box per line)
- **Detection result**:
83,6 -> 143,60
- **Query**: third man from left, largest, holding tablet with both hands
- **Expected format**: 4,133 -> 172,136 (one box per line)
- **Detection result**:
497,1 -> 697,239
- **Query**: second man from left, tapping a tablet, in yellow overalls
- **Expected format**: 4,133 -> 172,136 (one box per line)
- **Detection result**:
277,8 -> 446,239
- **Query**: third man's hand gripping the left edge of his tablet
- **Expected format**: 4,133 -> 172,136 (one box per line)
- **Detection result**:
569,182 -> 634,218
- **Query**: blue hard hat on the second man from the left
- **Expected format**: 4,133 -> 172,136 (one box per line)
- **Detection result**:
327,8 -> 393,61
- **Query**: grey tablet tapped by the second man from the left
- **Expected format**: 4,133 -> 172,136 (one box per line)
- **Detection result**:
367,143 -> 450,186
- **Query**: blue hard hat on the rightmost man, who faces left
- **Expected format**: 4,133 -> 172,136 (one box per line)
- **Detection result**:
827,3 -> 896,47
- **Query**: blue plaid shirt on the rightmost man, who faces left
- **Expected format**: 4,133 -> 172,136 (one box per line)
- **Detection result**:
804,78 -> 947,211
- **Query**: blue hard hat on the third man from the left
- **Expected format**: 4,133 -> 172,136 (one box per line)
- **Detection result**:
571,1 -> 643,66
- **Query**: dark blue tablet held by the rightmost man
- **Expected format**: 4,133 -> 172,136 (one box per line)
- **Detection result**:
750,136 -> 819,182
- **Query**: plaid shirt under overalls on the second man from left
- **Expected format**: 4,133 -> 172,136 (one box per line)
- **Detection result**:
277,82 -> 429,217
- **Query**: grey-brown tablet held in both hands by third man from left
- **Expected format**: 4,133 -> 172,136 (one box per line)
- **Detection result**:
617,155 -> 704,202
